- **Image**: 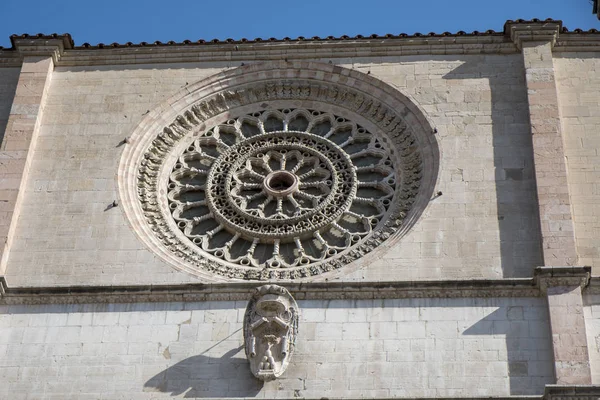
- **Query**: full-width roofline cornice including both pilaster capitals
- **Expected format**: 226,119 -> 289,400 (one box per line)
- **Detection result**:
0,19 -> 600,67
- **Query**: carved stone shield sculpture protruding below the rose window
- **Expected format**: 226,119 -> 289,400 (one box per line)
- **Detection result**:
244,285 -> 299,381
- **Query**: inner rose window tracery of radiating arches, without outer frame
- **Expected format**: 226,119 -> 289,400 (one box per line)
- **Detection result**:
167,109 -> 399,269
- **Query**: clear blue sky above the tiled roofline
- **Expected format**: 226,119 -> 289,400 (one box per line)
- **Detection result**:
0,0 -> 600,47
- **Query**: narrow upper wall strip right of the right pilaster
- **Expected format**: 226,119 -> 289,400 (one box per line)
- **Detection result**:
554,53 -> 600,275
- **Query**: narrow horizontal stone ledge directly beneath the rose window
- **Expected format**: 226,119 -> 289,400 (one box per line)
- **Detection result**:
0,277 -> 540,304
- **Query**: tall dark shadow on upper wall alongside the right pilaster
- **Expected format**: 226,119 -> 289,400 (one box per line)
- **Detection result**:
442,56 -> 542,278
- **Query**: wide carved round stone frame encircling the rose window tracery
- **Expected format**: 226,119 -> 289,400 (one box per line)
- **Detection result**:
119,62 -> 439,281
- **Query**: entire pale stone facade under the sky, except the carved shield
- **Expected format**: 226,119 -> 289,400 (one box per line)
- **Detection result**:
0,20 -> 600,399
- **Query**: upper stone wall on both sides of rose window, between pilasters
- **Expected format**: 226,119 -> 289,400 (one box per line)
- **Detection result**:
0,54 -> 542,286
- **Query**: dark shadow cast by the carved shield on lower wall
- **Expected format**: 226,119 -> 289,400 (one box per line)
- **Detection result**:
144,345 -> 263,398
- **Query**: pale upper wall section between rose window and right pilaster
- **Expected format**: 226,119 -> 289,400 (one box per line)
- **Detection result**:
346,54 -> 542,280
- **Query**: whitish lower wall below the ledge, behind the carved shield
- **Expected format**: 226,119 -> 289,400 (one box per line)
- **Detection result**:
0,298 -> 553,399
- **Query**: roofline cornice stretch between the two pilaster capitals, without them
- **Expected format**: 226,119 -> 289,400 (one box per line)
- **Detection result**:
0,33 -> 516,67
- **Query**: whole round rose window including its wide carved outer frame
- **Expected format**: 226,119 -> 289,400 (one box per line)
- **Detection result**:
119,63 -> 437,280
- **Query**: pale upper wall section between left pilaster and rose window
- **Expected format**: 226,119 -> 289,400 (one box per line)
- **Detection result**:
7,65 -> 227,285
